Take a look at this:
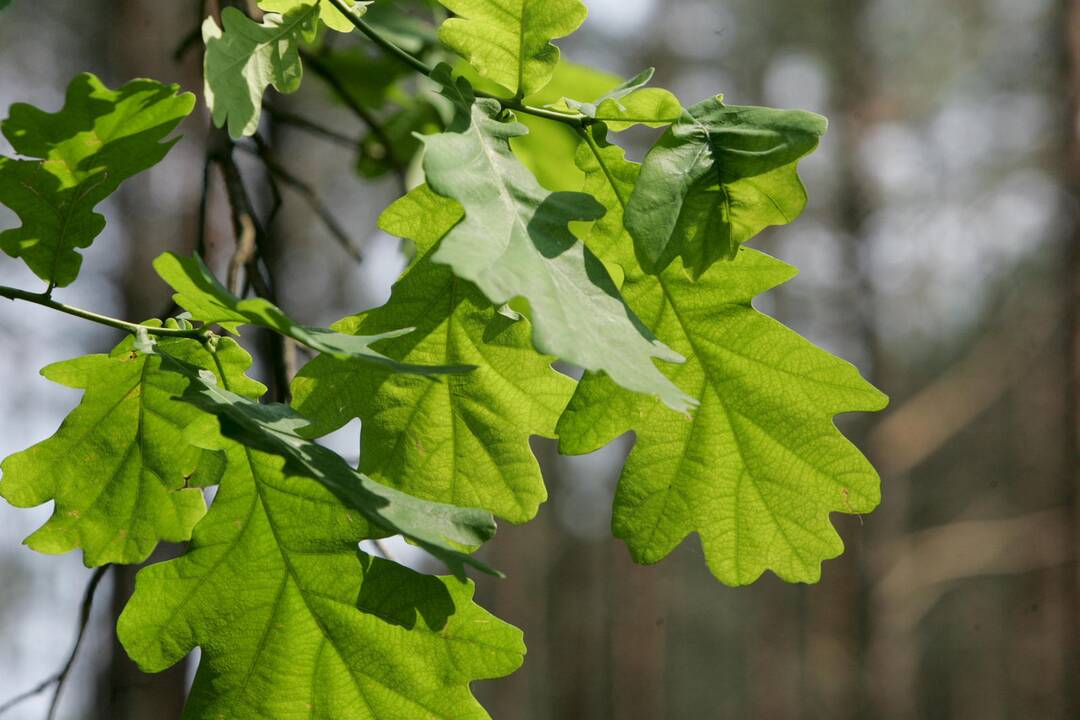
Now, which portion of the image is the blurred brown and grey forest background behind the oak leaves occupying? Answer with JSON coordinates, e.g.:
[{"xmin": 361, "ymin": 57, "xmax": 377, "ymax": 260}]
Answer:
[{"xmin": 0, "ymin": 0, "xmax": 1080, "ymax": 720}]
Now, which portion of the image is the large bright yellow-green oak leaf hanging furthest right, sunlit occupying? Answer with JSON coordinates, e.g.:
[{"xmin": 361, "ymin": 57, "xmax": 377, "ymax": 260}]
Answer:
[{"xmin": 558, "ymin": 129, "xmax": 887, "ymax": 585}]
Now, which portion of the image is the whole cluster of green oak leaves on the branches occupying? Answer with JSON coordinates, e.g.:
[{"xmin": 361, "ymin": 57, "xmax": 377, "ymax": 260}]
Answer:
[{"xmin": 0, "ymin": 0, "xmax": 886, "ymax": 718}]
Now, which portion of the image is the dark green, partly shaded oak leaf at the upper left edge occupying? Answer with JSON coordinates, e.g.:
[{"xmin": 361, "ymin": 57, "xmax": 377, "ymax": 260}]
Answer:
[{"xmin": 0, "ymin": 73, "xmax": 194, "ymax": 287}]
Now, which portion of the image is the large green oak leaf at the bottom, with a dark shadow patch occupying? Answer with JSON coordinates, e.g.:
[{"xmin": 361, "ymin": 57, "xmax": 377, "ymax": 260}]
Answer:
[{"xmin": 117, "ymin": 427, "xmax": 525, "ymax": 720}]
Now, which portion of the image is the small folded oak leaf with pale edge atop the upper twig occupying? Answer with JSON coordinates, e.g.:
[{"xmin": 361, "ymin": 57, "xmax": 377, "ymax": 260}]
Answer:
[{"xmin": 552, "ymin": 68, "xmax": 685, "ymax": 133}]
